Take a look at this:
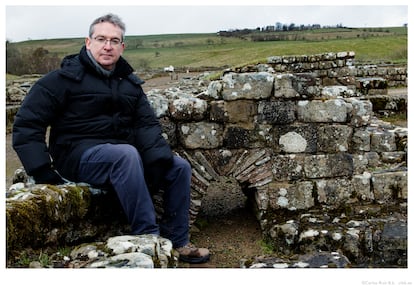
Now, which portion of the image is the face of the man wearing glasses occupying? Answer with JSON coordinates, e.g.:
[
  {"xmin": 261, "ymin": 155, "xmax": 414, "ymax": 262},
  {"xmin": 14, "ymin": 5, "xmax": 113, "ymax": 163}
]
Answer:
[{"xmin": 85, "ymin": 22, "xmax": 125, "ymax": 70}]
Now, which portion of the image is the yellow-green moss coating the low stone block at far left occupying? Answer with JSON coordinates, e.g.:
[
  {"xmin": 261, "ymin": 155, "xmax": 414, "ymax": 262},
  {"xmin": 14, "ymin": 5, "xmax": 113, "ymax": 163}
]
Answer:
[{"xmin": 6, "ymin": 185, "xmax": 91, "ymax": 255}]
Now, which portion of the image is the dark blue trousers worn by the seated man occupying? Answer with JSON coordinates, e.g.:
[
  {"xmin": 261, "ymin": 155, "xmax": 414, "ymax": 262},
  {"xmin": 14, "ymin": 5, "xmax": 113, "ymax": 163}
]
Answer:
[{"xmin": 78, "ymin": 144, "xmax": 191, "ymax": 248}]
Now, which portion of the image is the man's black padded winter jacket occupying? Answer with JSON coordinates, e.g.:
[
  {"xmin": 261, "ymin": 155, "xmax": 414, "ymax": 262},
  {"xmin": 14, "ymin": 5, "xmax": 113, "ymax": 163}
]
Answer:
[{"xmin": 13, "ymin": 47, "xmax": 172, "ymax": 181}]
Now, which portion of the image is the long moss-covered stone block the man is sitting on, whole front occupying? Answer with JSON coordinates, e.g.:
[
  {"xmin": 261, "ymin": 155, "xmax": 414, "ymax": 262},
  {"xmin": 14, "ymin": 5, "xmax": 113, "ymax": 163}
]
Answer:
[{"xmin": 6, "ymin": 183, "xmax": 129, "ymax": 252}]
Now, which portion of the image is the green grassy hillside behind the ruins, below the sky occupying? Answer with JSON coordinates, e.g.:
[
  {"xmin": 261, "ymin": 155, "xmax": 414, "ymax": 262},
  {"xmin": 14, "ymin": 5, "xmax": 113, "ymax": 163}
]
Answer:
[{"xmin": 7, "ymin": 27, "xmax": 407, "ymax": 73}]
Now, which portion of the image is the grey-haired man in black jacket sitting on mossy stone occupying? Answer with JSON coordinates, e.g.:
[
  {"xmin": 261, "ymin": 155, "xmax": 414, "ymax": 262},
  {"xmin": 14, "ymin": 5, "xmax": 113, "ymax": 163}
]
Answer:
[{"xmin": 13, "ymin": 14, "xmax": 210, "ymax": 263}]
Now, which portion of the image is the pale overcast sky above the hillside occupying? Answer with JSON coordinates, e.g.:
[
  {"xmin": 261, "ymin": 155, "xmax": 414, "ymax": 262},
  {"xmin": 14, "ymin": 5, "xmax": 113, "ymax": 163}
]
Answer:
[{"xmin": 4, "ymin": 0, "xmax": 408, "ymax": 42}]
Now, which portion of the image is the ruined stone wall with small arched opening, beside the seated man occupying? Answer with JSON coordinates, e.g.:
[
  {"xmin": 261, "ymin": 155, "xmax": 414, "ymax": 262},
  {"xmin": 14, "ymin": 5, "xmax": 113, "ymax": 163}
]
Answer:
[{"xmin": 149, "ymin": 53, "xmax": 408, "ymax": 264}]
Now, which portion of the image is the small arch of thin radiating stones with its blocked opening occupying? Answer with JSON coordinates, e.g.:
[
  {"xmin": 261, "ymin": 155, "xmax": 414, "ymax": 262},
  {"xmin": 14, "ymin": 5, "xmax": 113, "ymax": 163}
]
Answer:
[{"xmin": 179, "ymin": 149, "xmax": 273, "ymax": 223}]
